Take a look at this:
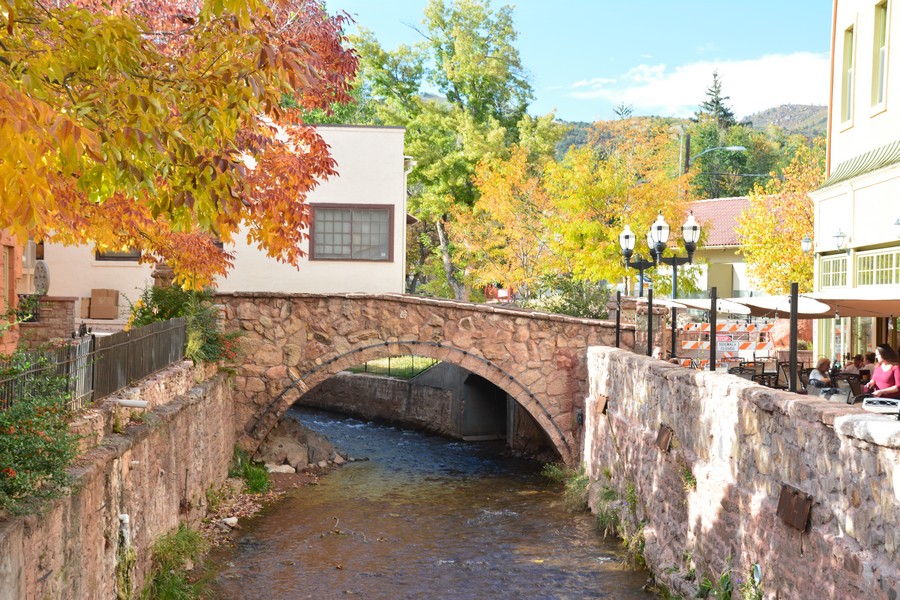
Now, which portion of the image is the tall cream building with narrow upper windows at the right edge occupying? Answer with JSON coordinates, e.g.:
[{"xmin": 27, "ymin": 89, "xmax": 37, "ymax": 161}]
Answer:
[{"xmin": 811, "ymin": 0, "xmax": 900, "ymax": 358}]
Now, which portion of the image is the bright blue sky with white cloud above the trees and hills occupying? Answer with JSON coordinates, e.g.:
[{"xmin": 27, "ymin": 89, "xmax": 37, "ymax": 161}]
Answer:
[{"xmin": 327, "ymin": 0, "xmax": 832, "ymax": 121}]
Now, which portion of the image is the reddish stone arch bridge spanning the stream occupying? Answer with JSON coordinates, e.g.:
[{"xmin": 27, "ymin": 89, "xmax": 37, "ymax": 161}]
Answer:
[{"xmin": 217, "ymin": 293, "xmax": 633, "ymax": 464}]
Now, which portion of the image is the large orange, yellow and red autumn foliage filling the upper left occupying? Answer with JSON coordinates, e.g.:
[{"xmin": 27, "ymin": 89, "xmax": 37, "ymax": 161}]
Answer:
[{"xmin": 0, "ymin": 0, "xmax": 357, "ymax": 286}]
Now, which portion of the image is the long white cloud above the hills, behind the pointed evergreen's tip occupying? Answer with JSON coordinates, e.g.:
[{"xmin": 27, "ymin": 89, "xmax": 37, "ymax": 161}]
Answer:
[{"xmin": 569, "ymin": 52, "xmax": 829, "ymax": 119}]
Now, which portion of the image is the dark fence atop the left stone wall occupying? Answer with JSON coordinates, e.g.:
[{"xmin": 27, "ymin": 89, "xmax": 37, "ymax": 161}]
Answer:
[{"xmin": 0, "ymin": 318, "xmax": 187, "ymax": 410}]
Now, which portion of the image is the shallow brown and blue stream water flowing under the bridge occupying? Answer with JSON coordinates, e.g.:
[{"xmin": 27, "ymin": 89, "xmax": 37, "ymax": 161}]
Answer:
[{"xmin": 212, "ymin": 409, "xmax": 650, "ymax": 599}]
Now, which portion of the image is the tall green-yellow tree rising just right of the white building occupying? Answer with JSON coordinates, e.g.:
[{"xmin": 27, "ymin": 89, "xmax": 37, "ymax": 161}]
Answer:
[{"xmin": 355, "ymin": 0, "xmax": 562, "ymax": 299}]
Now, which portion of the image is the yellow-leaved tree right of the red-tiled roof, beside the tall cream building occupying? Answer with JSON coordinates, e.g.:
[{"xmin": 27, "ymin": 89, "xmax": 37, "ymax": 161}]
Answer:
[{"xmin": 736, "ymin": 139, "xmax": 825, "ymax": 294}]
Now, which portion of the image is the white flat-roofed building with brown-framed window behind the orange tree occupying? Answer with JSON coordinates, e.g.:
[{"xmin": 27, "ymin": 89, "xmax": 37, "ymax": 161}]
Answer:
[{"xmin": 43, "ymin": 125, "xmax": 411, "ymax": 316}]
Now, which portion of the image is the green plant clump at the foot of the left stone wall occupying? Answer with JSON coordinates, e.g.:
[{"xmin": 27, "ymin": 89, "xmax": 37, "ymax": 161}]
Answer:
[{"xmin": 141, "ymin": 525, "xmax": 209, "ymax": 600}]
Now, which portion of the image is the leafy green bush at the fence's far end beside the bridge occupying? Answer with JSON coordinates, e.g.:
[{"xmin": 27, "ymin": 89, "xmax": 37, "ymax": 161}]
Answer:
[{"xmin": 128, "ymin": 286, "xmax": 240, "ymax": 363}]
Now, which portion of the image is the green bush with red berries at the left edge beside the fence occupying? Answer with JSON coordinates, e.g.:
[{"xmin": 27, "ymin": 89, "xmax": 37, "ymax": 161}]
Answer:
[{"xmin": 0, "ymin": 353, "xmax": 78, "ymax": 513}]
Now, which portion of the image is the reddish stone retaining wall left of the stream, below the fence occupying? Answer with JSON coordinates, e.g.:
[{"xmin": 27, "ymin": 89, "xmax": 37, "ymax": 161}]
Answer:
[{"xmin": 0, "ymin": 362, "xmax": 235, "ymax": 600}]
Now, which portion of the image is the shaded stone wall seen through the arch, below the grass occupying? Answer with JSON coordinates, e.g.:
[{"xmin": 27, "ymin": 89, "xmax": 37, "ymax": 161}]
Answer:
[{"xmin": 299, "ymin": 373, "xmax": 454, "ymax": 435}]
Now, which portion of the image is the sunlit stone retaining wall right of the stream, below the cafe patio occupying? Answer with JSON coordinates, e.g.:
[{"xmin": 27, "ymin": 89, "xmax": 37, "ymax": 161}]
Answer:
[{"xmin": 583, "ymin": 347, "xmax": 900, "ymax": 600}]
